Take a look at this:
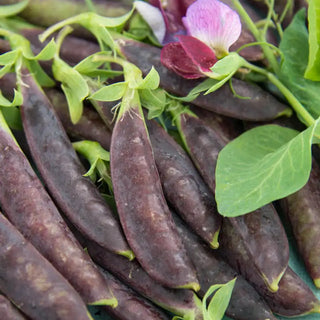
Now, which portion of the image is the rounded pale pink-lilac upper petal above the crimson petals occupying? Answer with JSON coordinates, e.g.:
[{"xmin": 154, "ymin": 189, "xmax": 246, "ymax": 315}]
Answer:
[{"xmin": 182, "ymin": 0, "xmax": 241, "ymax": 58}]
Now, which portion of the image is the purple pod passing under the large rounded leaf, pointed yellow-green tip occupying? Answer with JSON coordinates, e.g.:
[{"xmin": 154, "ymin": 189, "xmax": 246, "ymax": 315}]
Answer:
[{"xmin": 176, "ymin": 112, "xmax": 289, "ymax": 291}]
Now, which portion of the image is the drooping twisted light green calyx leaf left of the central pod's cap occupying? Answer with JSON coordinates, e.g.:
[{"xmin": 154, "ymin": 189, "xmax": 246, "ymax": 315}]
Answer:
[{"xmin": 52, "ymin": 56, "xmax": 89, "ymax": 123}]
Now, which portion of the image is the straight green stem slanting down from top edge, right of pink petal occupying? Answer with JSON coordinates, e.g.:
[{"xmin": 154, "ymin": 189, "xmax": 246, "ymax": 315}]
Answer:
[{"xmin": 231, "ymin": 0, "xmax": 279, "ymax": 73}]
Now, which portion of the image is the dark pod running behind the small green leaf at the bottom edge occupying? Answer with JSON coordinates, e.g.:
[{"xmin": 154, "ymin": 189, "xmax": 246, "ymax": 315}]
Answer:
[{"xmin": 174, "ymin": 215, "xmax": 276, "ymax": 320}]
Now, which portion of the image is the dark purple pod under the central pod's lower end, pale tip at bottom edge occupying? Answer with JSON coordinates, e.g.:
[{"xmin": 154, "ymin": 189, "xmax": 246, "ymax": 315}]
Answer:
[{"xmin": 86, "ymin": 242, "xmax": 202, "ymax": 320}]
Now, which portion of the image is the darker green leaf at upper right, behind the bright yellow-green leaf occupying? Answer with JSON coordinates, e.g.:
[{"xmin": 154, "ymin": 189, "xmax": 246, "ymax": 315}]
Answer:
[{"xmin": 278, "ymin": 10, "xmax": 320, "ymax": 118}]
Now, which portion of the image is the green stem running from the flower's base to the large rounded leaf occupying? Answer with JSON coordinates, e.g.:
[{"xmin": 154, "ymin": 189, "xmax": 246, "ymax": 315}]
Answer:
[{"xmin": 244, "ymin": 62, "xmax": 315, "ymax": 127}]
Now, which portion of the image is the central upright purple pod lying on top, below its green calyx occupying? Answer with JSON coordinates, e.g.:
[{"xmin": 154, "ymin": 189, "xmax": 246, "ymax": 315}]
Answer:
[{"xmin": 110, "ymin": 106, "xmax": 199, "ymax": 290}]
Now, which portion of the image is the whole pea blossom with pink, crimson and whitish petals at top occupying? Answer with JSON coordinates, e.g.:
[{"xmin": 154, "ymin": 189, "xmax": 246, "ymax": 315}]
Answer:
[{"xmin": 135, "ymin": 0, "xmax": 241, "ymax": 79}]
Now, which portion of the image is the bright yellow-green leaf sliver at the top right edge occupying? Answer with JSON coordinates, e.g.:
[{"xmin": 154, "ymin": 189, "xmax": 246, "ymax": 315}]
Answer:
[{"xmin": 304, "ymin": 0, "xmax": 320, "ymax": 81}]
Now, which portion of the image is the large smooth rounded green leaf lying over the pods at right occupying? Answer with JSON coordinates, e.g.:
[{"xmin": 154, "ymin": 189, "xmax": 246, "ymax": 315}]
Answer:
[{"xmin": 216, "ymin": 121, "xmax": 318, "ymax": 217}]
